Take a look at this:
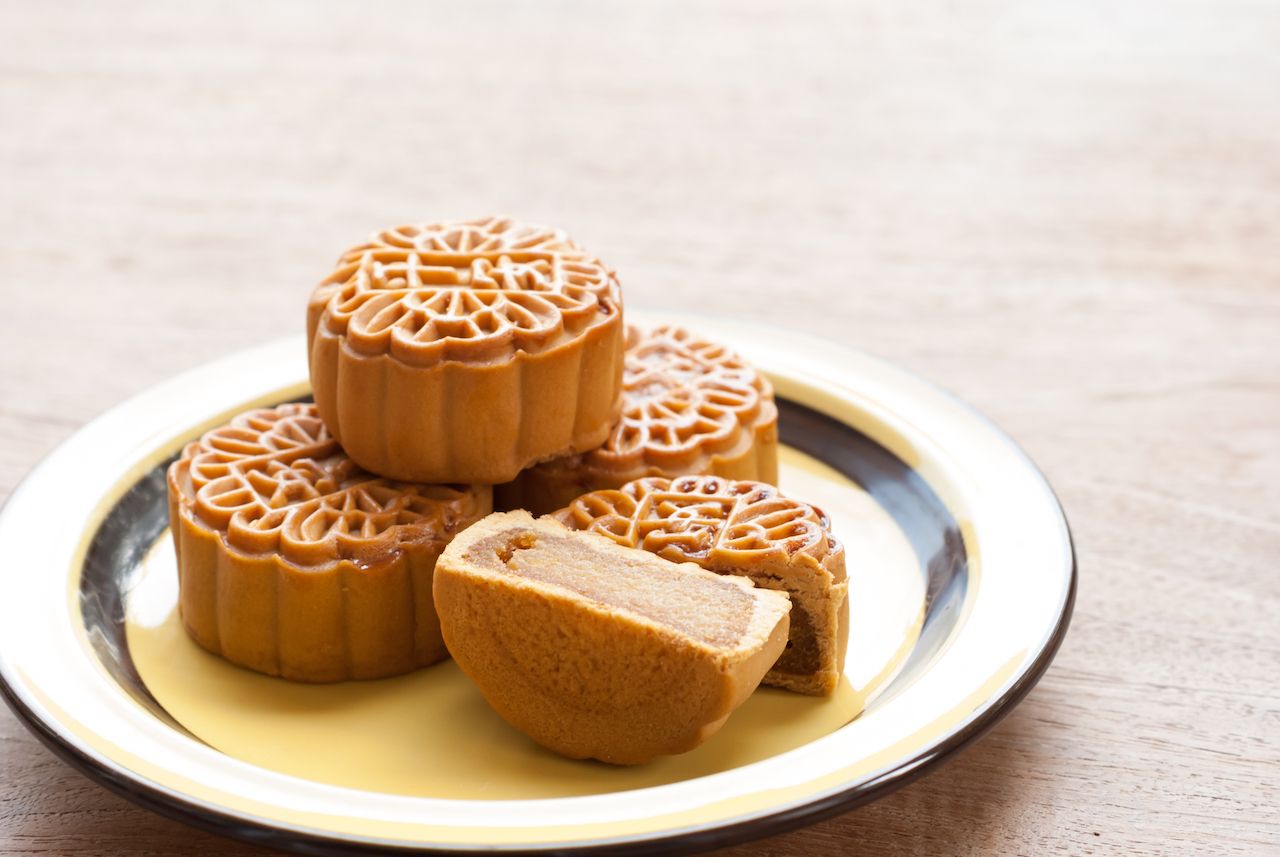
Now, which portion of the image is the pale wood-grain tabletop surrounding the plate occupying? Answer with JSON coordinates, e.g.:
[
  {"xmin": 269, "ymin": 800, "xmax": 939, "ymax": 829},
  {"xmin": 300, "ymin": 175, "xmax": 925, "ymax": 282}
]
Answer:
[{"xmin": 0, "ymin": 0, "xmax": 1280, "ymax": 856}]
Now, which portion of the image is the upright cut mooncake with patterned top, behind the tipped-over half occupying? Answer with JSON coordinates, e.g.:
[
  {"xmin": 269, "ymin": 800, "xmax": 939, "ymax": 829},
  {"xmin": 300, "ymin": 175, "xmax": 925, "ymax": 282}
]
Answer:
[{"xmin": 556, "ymin": 476, "xmax": 849, "ymax": 695}]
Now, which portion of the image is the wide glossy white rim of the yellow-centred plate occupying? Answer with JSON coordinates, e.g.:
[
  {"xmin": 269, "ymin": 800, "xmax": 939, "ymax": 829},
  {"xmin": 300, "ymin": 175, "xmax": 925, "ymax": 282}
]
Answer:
[{"xmin": 0, "ymin": 311, "xmax": 1075, "ymax": 851}]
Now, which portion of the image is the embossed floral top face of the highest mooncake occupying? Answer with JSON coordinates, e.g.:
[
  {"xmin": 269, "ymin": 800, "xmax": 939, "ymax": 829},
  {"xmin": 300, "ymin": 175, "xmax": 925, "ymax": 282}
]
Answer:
[{"xmin": 310, "ymin": 217, "xmax": 622, "ymax": 365}]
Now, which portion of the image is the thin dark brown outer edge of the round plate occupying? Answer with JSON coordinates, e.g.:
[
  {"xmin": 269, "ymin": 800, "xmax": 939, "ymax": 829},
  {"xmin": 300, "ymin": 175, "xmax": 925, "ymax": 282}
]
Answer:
[{"xmin": 0, "ymin": 318, "xmax": 1079, "ymax": 854}]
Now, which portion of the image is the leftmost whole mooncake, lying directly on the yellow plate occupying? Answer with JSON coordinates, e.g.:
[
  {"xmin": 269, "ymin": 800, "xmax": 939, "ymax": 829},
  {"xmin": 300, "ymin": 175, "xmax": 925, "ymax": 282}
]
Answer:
[{"xmin": 169, "ymin": 404, "xmax": 492, "ymax": 682}]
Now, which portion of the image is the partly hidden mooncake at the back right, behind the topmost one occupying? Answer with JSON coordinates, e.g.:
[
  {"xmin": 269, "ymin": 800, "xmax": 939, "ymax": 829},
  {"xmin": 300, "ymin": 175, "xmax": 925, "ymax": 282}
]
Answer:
[{"xmin": 494, "ymin": 327, "xmax": 778, "ymax": 514}]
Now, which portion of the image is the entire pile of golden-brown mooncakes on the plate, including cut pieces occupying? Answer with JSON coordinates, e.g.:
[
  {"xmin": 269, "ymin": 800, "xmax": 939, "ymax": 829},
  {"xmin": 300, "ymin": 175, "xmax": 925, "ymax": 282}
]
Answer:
[{"xmin": 169, "ymin": 217, "xmax": 847, "ymax": 764}]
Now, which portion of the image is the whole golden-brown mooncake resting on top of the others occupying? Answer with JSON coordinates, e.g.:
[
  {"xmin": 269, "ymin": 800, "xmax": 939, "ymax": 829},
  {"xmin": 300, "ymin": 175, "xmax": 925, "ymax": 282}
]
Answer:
[{"xmin": 307, "ymin": 217, "xmax": 625, "ymax": 484}]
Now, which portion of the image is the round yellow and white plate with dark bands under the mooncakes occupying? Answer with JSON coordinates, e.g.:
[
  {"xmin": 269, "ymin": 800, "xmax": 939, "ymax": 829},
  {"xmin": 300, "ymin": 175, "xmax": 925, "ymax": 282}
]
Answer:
[{"xmin": 0, "ymin": 312, "xmax": 1075, "ymax": 853}]
